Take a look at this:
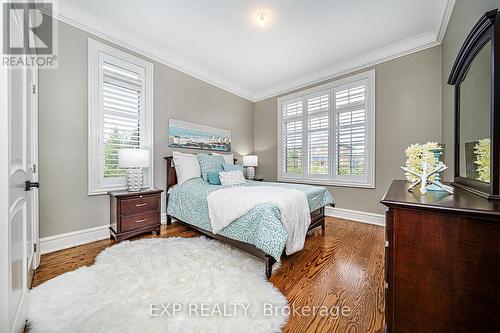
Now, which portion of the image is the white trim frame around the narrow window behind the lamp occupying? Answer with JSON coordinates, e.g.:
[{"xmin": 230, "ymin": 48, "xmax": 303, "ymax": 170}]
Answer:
[{"xmin": 87, "ymin": 38, "xmax": 154, "ymax": 196}]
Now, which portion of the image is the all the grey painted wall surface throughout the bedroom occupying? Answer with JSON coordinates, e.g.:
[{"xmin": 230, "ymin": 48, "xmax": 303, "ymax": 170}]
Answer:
[{"xmin": 39, "ymin": 0, "xmax": 500, "ymax": 237}]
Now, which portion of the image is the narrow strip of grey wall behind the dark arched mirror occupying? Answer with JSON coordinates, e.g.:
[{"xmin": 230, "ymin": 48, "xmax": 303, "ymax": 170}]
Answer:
[{"xmin": 441, "ymin": 0, "xmax": 500, "ymax": 180}]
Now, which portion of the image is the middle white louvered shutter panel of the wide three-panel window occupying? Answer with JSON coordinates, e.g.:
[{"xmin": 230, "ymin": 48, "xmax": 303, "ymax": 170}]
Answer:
[{"xmin": 306, "ymin": 90, "xmax": 330, "ymax": 176}]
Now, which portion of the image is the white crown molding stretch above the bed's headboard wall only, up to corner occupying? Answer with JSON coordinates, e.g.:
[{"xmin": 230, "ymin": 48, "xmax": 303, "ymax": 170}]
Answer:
[{"xmin": 53, "ymin": 0, "xmax": 254, "ymax": 101}]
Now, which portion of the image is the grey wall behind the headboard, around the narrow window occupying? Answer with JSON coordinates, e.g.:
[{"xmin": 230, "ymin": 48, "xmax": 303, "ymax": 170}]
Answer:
[{"xmin": 39, "ymin": 22, "xmax": 253, "ymax": 237}]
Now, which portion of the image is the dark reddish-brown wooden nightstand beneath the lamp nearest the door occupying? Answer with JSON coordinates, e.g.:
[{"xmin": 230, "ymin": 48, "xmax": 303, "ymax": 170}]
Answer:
[{"xmin": 109, "ymin": 189, "xmax": 163, "ymax": 242}]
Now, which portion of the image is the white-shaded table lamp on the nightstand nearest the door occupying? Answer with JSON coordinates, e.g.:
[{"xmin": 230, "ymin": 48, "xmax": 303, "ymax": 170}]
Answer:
[{"xmin": 118, "ymin": 148, "xmax": 149, "ymax": 192}]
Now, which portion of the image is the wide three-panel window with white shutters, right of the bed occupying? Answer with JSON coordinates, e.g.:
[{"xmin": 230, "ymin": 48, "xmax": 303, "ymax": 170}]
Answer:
[{"xmin": 278, "ymin": 70, "xmax": 375, "ymax": 188}]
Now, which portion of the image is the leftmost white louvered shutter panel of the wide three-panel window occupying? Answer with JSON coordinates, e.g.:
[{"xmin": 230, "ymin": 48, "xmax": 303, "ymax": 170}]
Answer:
[{"xmin": 281, "ymin": 100, "xmax": 304, "ymax": 176}]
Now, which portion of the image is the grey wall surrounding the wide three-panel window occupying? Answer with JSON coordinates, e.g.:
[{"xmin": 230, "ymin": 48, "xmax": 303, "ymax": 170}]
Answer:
[{"xmin": 254, "ymin": 46, "xmax": 441, "ymax": 213}]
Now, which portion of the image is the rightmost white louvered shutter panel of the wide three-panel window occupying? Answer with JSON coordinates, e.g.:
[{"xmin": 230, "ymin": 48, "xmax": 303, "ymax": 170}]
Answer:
[{"xmin": 333, "ymin": 80, "xmax": 368, "ymax": 178}]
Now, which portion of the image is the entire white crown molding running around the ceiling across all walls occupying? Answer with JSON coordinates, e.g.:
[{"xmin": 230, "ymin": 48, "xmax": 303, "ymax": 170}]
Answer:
[{"xmin": 49, "ymin": 0, "xmax": 455, "ymax": 102}]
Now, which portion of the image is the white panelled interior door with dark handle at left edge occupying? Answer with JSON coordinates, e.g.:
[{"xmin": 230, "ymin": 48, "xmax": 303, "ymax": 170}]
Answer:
[{"xmin": 0, "ymin": 5, "xmax": 38, "ymax": 332}]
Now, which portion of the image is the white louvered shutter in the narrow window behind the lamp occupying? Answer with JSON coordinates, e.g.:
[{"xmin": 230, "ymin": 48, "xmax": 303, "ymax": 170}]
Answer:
[{"xmin": 100, "ymin": 54, "xmax": 144, "ymax": 181}]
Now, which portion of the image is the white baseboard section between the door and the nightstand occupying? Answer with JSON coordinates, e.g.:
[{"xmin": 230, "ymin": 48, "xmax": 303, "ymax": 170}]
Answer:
[{"xmin": 40, "ymin": 224, "xmax": 109, "ymax": 254}]
